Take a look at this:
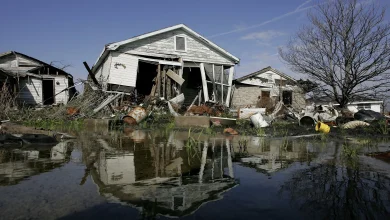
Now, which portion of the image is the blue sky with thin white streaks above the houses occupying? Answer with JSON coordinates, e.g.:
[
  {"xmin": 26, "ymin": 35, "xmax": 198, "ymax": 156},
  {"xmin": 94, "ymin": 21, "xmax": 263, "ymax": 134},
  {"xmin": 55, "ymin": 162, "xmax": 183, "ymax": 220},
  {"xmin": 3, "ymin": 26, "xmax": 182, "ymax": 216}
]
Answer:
[{"xmin": 0, "ymin": 0, "xmax": 390, "ymax": 86}]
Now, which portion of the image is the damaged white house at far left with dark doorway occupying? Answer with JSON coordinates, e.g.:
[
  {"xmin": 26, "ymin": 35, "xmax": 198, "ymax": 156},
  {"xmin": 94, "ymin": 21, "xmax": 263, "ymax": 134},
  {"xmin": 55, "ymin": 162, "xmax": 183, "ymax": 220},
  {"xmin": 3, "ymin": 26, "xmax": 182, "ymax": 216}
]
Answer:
[{"xmin": 0, "ymin": 51, "xmax": 76, "ymax": 105}]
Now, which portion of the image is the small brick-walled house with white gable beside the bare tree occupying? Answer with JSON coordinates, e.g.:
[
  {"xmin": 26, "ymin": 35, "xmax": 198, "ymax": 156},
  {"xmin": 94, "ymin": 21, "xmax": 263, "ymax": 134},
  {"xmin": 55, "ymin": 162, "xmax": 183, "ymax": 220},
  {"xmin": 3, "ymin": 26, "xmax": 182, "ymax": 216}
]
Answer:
[{"xmin": 232, "ymin": 66, "xmax": 305, "ymax": 110}]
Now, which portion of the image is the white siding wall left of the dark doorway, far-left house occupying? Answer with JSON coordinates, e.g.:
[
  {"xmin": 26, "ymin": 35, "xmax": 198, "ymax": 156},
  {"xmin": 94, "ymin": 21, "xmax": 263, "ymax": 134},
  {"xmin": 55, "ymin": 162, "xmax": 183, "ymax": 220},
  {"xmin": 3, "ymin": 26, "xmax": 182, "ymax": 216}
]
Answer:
[{"xmin": 18, "ymin": 77, "xmax": 42, "ymax": 104}]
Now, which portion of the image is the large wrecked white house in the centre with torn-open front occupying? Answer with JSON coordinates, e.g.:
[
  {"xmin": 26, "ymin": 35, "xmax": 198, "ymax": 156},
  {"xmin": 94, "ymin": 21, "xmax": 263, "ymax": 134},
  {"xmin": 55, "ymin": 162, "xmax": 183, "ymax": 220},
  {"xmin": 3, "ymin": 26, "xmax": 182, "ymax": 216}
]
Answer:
[{"xmin": 92, "ymin": 24, "xmax": 239, "ymax": 105}]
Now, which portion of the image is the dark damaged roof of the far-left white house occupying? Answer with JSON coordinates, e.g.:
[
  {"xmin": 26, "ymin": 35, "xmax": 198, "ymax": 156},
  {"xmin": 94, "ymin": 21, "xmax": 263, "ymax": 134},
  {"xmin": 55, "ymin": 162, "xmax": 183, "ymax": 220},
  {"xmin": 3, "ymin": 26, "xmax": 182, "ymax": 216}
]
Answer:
[{"xmin": 0, "ymin": 51, "xmax": 72, "ymax": 77}]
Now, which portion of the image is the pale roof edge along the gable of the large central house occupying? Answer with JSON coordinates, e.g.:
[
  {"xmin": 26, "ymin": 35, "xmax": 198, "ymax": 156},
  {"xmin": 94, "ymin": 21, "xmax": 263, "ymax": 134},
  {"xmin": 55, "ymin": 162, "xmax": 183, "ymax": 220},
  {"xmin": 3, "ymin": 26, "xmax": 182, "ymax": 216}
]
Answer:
[{"xmin": 93, "ymin": 24, "xmax": 240, "ymax": 69}]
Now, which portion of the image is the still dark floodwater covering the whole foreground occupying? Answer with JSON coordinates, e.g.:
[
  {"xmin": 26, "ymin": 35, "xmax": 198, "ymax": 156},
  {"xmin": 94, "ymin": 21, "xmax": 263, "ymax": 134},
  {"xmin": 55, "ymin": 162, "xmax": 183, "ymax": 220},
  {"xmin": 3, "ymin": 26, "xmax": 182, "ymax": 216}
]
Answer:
[{"xmin": 0, "ymin": 129, "xmax": 390, "ymax": 219}]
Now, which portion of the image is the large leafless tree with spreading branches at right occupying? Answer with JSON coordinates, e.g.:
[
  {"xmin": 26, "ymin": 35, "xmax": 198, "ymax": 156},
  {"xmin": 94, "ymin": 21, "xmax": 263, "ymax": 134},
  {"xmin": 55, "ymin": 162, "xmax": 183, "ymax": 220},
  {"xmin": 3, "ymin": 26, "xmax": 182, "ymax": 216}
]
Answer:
[{"xmin": 279, "ymin": 0, "xmax": 390, "ymax": 107}]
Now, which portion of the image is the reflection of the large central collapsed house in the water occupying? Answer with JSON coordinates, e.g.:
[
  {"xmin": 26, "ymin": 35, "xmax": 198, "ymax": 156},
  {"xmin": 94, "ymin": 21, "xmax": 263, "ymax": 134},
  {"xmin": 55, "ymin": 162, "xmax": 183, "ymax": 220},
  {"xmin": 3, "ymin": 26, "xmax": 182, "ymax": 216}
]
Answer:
[{"xmin": 92, "ymin": 131, "xmax": 237, "ymax": 216}]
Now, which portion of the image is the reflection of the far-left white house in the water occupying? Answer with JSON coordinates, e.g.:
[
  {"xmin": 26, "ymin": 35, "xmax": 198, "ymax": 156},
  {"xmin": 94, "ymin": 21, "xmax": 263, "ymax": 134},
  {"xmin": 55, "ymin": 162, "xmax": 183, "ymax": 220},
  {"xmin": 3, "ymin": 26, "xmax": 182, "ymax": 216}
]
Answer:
[{"xmin": 0, "ymin": 142, "xmax": 72, "ymax": 185}]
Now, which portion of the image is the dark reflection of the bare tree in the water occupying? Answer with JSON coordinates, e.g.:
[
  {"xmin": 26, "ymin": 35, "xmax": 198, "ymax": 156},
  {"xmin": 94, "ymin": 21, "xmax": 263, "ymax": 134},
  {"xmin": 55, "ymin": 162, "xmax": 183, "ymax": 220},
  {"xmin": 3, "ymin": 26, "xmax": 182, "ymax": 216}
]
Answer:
[{"xmin": 280, "ymin": 142, "xmax": 390, "ymax": 219}]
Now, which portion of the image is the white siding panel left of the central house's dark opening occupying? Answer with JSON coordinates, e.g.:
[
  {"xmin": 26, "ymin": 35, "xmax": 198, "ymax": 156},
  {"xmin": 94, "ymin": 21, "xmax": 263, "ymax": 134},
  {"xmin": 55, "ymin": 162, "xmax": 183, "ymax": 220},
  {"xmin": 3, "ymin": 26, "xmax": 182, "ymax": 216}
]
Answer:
[{"xmin": 109, "ymin": 52, "xmax": 138, "ymax": 87}]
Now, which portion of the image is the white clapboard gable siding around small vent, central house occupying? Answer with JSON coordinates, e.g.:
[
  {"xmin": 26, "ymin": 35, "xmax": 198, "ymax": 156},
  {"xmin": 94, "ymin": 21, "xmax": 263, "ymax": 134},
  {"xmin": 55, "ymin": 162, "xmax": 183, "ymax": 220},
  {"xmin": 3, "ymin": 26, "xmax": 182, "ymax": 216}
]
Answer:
[{"xmin": 119, "ymin": 30, "xmax": 234, "ymax": 65}]
